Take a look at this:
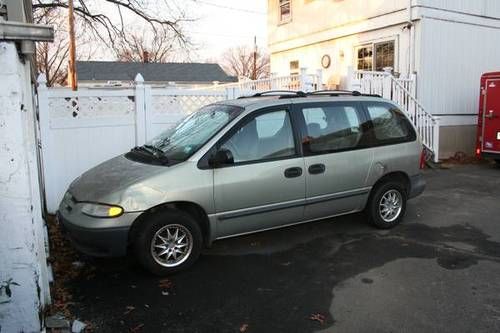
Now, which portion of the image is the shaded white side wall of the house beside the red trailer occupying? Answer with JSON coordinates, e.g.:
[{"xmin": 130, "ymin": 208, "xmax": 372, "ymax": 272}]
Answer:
[{"xmin": 419, "ymin": 16, "xmax": 500, "ymax": 126}]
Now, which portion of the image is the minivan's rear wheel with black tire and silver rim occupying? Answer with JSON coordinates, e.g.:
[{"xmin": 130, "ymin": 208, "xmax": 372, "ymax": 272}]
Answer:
[{"xmin": 366, "ymin": 181, "xmax": 407, "ymax": 229}]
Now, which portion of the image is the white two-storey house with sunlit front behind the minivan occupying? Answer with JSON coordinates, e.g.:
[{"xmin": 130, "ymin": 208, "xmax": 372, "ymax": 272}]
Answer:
[{"xmin": 268, "ymin": 0, "xmax": 500, "ymax": 157}]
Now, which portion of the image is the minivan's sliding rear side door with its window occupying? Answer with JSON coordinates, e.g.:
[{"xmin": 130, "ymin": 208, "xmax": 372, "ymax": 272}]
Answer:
[{"xmin": 294, "ymin": 102, "xmax": 373, "ymax": 220}]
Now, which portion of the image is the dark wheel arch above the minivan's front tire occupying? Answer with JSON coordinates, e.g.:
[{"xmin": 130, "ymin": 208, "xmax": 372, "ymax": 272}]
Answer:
[{"xmin": 128, "ymin": 201, "xmax": 211, "ymax": 248}]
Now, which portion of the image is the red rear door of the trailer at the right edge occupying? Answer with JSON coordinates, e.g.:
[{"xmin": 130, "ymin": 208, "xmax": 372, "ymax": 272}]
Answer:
[{"xmin": 482, "ymin": 79, "xmax": 500, "ymax": 153}]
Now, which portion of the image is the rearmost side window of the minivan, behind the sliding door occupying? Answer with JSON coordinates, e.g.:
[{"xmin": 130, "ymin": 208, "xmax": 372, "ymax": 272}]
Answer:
[{"xmin": 365, "ymin": 103, "xmax": 416, "ymax": 145}]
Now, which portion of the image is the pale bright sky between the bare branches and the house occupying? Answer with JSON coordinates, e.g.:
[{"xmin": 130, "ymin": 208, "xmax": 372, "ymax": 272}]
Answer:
[{"xmin": 93, "ymin": 0, "xmax": 267, "ymax": 62}]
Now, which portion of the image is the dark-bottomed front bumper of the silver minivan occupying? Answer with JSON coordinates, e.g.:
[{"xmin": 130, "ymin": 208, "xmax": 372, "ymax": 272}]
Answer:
[{"xmin": 57, "ymin": 197, "xmax": 140, "ymax": 257}]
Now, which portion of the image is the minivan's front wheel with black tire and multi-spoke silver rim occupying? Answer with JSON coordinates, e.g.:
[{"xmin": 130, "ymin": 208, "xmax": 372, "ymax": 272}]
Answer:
[{"xmin": 134, "ymin": 210, "xmax": 203, "ymax": 276}]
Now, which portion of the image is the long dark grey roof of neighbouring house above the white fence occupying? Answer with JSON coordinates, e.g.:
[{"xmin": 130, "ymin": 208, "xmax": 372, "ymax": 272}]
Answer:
[{"xmin": 76, "ymin": 61, "xmax": 238, "ymax": 83}]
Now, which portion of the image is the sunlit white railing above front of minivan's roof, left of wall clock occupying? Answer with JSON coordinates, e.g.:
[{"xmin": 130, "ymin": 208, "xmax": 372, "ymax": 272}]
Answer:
[{"xmin": 203, "ymin": 68, "xmax": 323, "ymax": 98}]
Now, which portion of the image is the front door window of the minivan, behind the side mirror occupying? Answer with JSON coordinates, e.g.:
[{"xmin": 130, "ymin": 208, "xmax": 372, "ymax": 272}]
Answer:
[{"xmin": 221, "ymin": 110, "xmax": 295, "ymax": 163}]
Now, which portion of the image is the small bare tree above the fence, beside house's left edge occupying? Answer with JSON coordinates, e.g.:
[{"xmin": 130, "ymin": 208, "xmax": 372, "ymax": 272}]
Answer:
[{"xmin": 221, "ymin": 46, "xmax": 270, "ymax": 79}]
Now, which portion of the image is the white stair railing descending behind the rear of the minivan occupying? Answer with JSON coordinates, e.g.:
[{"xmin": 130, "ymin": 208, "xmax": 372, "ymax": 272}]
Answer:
[{"xmin": 347, "ymin": 69, "xmax": 439, "ymax": 162}]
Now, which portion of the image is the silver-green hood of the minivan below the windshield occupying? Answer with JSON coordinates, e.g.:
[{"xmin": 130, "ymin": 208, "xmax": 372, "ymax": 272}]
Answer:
[{"xmin": 69, "ymin": 155, "xmax": 167, "ymax": 204}]
